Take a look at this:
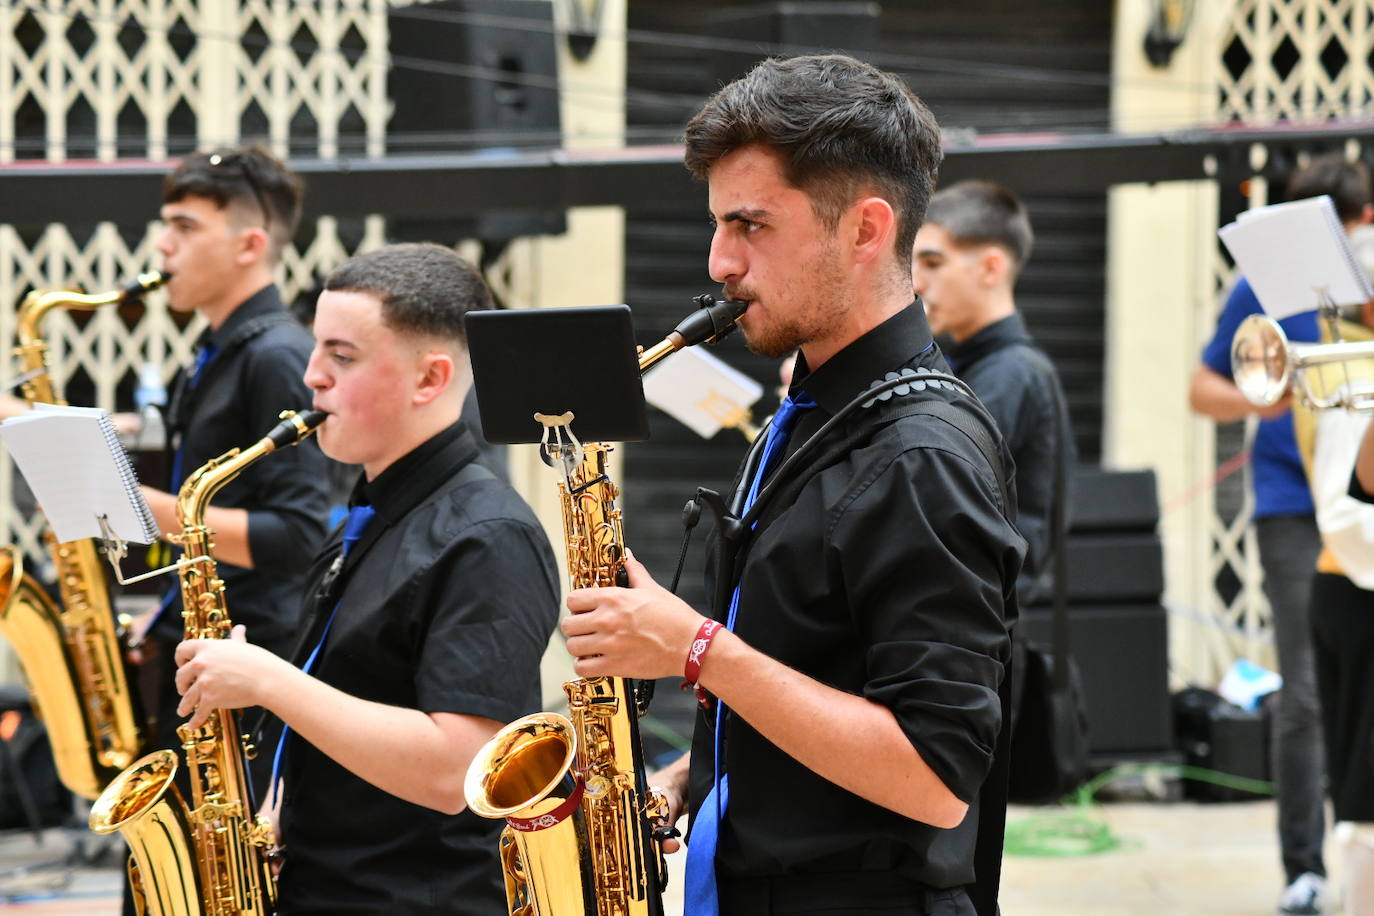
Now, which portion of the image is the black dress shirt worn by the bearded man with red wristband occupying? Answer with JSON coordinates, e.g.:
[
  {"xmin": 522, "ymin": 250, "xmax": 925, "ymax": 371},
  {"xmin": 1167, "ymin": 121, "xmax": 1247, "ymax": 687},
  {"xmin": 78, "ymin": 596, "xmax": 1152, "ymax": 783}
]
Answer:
[{"xmin": 691, "ymin": 306, "xmax": 1025, "ymax": 889}]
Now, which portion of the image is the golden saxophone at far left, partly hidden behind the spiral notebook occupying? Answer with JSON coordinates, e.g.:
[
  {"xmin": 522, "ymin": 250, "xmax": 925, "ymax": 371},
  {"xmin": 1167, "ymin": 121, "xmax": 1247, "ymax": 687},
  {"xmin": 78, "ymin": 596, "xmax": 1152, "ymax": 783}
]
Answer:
[{"xmin": 0, "ymin": 272, "xmax": 168, "ymax": 798}]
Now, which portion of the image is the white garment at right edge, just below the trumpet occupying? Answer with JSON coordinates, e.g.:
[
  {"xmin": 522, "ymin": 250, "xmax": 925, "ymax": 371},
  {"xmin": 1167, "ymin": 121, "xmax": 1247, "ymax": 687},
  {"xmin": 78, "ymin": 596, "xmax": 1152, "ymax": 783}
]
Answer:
[{"xmin": 1312, "ymin": 409, "xmax": 1374, "ymax": 589}]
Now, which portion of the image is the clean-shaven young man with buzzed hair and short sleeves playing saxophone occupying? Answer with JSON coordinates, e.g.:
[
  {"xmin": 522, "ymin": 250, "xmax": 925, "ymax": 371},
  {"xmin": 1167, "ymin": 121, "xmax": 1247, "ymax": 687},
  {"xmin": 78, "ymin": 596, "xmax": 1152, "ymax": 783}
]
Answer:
[{"xmin": 177, "ymin": 244, "xmax": 559, "ymax": 916}]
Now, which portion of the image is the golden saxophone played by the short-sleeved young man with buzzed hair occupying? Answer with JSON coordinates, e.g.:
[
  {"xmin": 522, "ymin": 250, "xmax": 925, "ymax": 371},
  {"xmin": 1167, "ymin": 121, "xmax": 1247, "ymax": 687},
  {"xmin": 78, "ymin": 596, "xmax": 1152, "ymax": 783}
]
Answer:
[{"xmin": 91, "ymin": 411, "xmax": 327, "ymax": 916}]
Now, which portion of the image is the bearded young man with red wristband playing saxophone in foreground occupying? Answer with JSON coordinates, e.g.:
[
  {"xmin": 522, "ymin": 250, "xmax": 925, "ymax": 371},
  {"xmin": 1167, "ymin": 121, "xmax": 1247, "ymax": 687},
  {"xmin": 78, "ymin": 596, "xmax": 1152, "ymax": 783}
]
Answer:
[{"xmin": 563, "ymin": 56, "xmax": 1025, "ymax": 916}]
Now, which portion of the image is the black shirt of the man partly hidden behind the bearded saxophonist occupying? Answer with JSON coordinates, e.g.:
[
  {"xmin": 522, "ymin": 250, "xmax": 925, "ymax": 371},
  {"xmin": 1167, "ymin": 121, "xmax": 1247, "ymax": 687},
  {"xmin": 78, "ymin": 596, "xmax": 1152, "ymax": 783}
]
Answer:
[{"xmin": 945, "ymin": 314, "xmax": 1076, "ymax": 606}]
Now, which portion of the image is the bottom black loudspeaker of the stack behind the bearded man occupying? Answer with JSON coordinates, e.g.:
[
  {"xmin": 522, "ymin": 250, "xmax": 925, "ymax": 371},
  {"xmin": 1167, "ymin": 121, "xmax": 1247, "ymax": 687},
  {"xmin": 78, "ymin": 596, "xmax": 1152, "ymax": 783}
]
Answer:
[{"xmin": 1013, "ymin": 604, "xmax": 1173, "ymax": 766}]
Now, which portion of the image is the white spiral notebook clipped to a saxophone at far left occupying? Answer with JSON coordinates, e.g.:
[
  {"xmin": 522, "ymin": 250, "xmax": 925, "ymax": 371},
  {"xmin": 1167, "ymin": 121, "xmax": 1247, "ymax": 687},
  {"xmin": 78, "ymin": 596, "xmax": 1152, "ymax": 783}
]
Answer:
[{"xmin": 0, "ymin": 404, "xmax": 158, "ymax": 544}]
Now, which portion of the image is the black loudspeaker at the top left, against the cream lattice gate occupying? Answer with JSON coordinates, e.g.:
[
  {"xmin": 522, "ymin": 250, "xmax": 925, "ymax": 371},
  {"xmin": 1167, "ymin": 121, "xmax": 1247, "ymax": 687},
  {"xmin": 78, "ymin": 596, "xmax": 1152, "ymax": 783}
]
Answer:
[{"xmin": 386, "ymin": 0, "xmax": 567, "ymax": 242}]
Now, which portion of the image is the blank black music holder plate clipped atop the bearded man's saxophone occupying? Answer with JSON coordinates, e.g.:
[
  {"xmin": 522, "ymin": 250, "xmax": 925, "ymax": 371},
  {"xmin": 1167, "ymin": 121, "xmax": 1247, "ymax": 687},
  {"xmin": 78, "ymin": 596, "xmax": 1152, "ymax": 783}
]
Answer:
[{"xmin": 464, "ymin": 305, "xmax": 649, "ymax": 444}]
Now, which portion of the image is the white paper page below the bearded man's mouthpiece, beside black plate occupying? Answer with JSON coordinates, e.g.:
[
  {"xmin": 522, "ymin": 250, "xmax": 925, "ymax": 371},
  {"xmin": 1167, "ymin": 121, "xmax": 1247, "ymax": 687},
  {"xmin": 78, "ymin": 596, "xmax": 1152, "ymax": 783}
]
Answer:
[{"xmin": 644, "ymin": 347, "xmax": 764, "ymax": 439}]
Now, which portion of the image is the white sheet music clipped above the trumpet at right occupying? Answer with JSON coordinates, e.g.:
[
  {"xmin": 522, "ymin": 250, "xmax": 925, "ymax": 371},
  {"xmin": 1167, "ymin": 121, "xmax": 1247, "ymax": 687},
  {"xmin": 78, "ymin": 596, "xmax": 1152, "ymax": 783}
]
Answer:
[{"xmin": 1217, "ymin": 195, "xmax": 1374, "ymax": 319}]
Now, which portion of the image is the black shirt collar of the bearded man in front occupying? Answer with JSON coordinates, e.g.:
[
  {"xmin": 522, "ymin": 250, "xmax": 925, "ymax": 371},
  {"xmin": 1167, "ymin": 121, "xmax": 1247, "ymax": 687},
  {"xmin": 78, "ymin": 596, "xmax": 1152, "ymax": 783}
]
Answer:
[{"xmin": 789, "ymin": 302, "xmax": 932, "ymax": 413}]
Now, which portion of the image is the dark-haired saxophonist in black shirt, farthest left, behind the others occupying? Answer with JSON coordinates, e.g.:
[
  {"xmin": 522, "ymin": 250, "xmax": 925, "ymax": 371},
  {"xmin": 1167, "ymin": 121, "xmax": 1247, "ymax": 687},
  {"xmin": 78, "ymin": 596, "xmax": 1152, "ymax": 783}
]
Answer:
[{"xmin": 126, "ymin": 147, "xmax": 328, "ymax": 829}]
